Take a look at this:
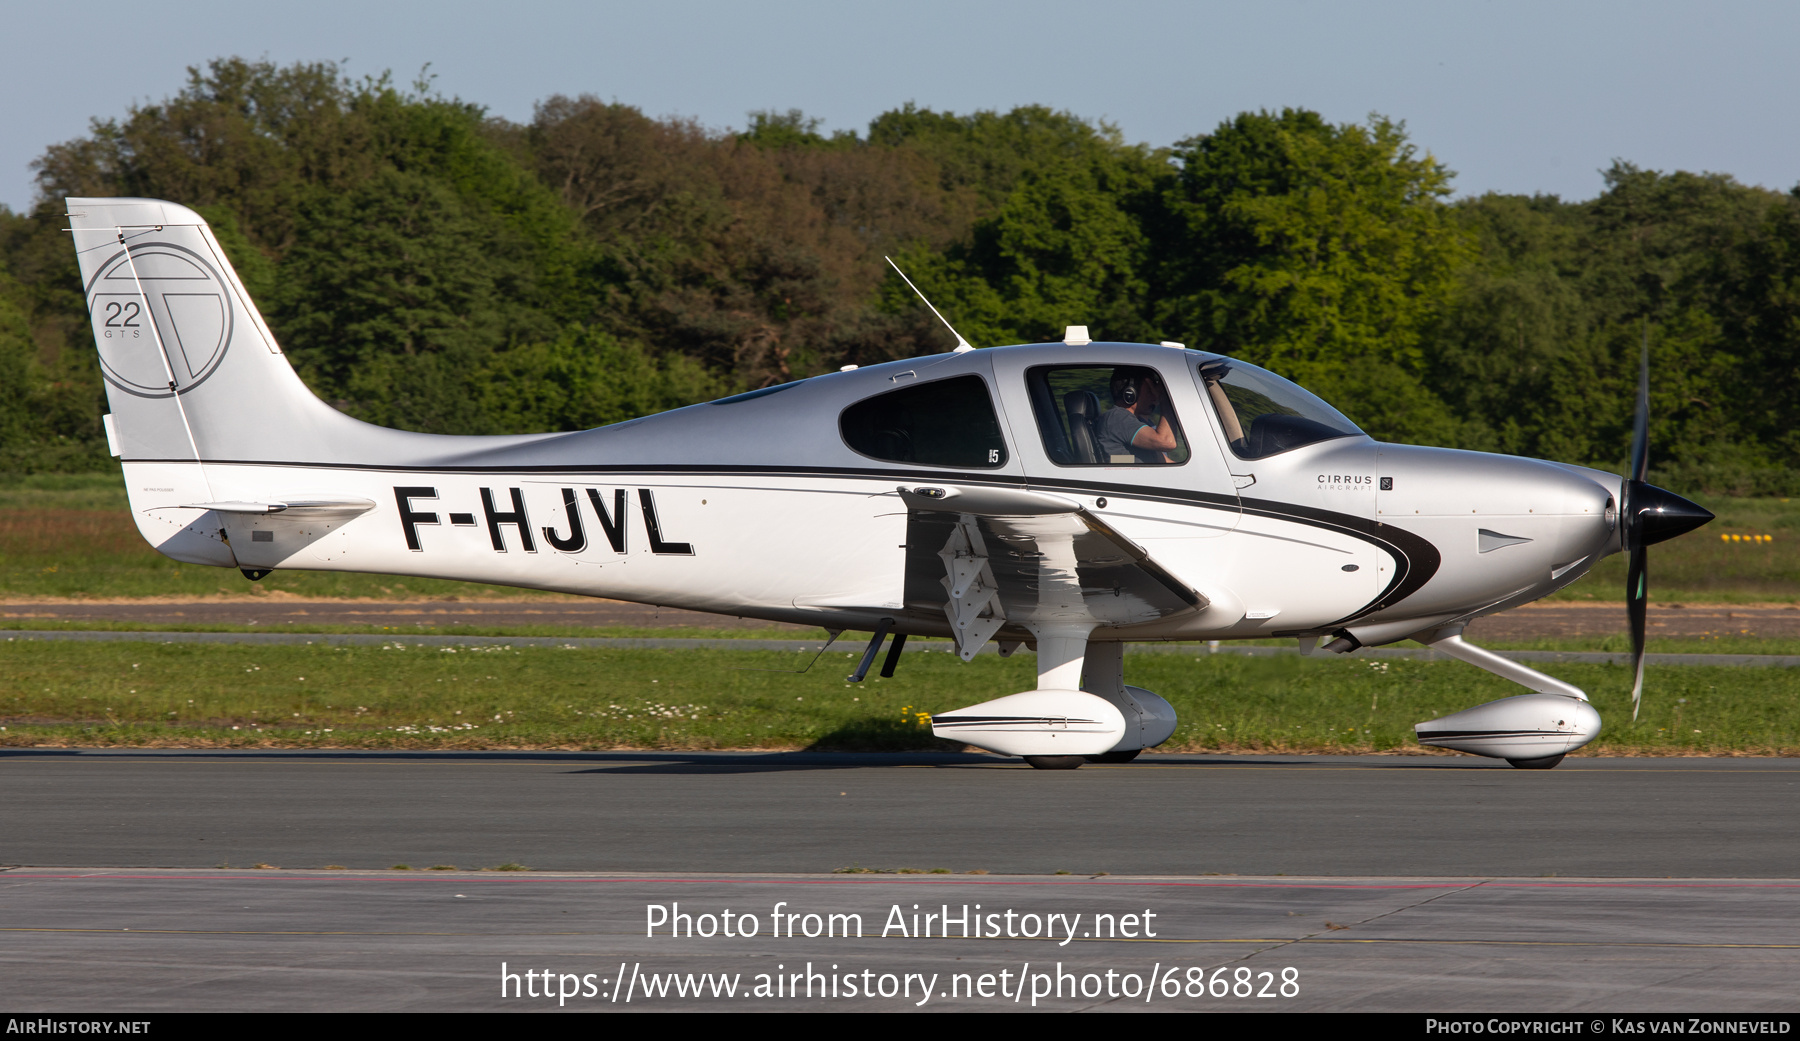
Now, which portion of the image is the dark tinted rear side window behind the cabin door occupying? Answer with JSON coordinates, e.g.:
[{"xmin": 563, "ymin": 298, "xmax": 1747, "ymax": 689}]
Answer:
[{"xmin": 837, "ymin": 376, "xmax": 1006, "ymax": 470}]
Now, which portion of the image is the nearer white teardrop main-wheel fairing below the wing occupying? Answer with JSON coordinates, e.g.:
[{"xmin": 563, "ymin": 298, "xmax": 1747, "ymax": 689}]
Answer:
[{"xmin": 931, "ymin": 690, "xmax": 1116, "ymax": 756}]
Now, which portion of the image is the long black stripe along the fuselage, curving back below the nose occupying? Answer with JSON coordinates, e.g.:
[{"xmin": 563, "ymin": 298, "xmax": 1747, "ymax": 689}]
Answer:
[{"xmin": 124, "ymin": 452, "xmax": 1444, "ymax": 615}]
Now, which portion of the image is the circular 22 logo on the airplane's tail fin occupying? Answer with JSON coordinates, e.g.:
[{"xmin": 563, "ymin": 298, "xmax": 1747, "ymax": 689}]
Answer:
[{"xmin": 88, "ymin": 243, "xmax": 234, "ymax": 398}]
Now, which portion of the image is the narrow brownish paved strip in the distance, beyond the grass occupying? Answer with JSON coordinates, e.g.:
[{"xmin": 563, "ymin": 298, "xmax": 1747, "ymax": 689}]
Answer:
[{"xmin": 0, "ymin": 596, "xmax": 1800, "ymax": 643}]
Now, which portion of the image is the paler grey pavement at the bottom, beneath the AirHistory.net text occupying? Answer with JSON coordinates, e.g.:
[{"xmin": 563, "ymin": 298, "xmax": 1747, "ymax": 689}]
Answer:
[{"xmin": 0, "ymin": 870, "xmax": 1800, "ymax": 1008}]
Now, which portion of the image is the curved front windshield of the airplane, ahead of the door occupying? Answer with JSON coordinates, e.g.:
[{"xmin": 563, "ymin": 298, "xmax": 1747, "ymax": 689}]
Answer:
[{"xmin": 1193, "ymin": 355, "xmax": 1363, "ymax": 459}]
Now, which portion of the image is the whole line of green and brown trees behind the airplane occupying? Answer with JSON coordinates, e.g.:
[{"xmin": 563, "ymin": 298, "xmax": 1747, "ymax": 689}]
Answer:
[{"xmin": 0, "ymin": 58, "xmax": 1800, "ymax": 493}]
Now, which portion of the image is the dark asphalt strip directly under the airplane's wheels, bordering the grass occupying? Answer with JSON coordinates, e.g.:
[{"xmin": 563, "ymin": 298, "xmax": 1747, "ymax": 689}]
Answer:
[{"xmin": 0, "ymin": 749, "xmax": 1800, "ymax": 877}]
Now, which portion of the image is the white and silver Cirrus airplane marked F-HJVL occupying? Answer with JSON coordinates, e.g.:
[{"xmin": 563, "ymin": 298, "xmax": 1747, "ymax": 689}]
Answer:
[{"xmin": 68, "ymin": 198, "xmax": 1712, "ymax": 769}]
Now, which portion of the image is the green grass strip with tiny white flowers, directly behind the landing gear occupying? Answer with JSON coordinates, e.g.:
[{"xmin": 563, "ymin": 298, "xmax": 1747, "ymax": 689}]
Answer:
[{"xmin": 0, "ymin": 643, "xmax": 1800, "ymax": 755}]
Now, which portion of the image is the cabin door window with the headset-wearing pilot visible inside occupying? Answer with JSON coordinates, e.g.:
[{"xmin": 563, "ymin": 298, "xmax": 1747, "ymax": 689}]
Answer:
[{"xmin": 1026, "ymin": 366, "xmax": 1188, "ymax": 466}]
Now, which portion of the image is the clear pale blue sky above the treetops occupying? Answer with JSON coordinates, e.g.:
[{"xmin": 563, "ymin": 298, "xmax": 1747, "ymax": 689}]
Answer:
[{"xmin": 0, "ymin": 0, "xmax": 1800, "ymax": 209}]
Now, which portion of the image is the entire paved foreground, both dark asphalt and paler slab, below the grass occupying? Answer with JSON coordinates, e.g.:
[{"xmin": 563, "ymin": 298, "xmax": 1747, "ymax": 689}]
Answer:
[{"xmin": 0, "ymin": 749, "xmax": 1800, "ymax": 1012}]
